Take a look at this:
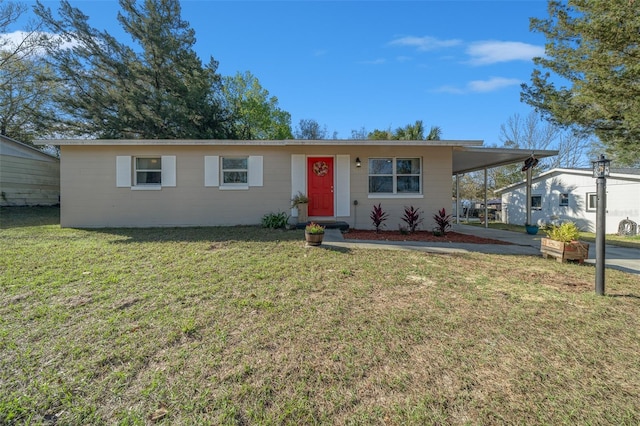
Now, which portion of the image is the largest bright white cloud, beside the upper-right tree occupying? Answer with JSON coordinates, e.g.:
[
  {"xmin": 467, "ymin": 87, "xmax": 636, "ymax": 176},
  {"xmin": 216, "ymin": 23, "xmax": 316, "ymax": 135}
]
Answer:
[{"xmin": 467, "ymin": 41, "xmax": 544, "ymax": 65}]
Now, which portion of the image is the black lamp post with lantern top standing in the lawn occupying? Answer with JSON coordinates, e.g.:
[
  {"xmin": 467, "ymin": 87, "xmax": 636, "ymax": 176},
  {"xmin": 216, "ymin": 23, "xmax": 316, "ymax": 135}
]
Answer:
[{"xmin": 593, "ymin": 154, "xmax": 611, "ymax": 296}]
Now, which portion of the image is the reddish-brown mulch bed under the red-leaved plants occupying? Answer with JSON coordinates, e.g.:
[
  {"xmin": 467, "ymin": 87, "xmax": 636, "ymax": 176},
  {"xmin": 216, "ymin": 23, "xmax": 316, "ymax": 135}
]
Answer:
[{"xmin": 343, "ymin": 229, "xmax": 511, "ymax": 245}]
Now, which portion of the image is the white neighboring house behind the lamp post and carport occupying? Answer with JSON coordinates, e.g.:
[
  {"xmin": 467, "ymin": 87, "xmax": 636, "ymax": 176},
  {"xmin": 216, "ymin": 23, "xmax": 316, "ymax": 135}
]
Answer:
[{"xmin": 495, "ymin": 169, "xmax": 640, "ymax": 234}]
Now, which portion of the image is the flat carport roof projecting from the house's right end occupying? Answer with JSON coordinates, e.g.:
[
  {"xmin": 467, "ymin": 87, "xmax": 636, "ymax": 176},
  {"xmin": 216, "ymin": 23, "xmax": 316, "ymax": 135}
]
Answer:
[{"xmin": 452, "ymin": 146, "xmax": 558, "ymax": 175}]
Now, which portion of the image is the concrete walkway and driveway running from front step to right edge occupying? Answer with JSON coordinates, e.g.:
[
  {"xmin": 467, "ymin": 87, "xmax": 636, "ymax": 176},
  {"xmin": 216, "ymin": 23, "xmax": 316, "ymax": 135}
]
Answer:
[{"xmin": 323, "ymin": 224, "xmax": 640, "ymax": 274}]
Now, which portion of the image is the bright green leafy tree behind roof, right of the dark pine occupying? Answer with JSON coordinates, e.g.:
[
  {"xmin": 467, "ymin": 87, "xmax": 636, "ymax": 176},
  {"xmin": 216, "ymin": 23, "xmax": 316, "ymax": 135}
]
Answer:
[{"xmin": 222, "ymin": 71, "xmax": 293, "ymax": 140}]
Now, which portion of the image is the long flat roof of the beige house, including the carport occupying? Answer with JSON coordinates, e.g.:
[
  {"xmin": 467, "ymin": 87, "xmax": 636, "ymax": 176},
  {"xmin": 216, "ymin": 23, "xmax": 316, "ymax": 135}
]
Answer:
[{"xmin": 35, "ymin": 139, "xmax": 558, "ymax": 174}]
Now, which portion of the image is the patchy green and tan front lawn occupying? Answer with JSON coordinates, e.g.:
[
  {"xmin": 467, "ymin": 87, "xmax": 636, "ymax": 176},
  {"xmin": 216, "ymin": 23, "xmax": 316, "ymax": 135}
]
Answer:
[{"xmin": 0, "ymin": 209, "xmax": 640, "ymax": 425}]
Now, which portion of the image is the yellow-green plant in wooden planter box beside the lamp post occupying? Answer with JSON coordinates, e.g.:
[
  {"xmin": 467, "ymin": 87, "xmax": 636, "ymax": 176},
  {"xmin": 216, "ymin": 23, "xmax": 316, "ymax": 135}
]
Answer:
[{"xmin": 540, "ymin": 222, "xmax": 589, "ymax": 263}]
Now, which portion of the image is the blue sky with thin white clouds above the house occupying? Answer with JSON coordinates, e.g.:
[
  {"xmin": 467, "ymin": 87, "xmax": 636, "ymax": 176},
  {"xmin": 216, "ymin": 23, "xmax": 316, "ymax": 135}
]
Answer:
[{"xmin": 17, "ymin": 0, "xmax": 547, "ymax": 145}]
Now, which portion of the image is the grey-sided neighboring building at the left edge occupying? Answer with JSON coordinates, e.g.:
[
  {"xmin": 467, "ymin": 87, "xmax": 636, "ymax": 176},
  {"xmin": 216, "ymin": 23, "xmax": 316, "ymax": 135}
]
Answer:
[{"xmin": 0, "ymin": 135, "xmax": 60, "ymax": 206}]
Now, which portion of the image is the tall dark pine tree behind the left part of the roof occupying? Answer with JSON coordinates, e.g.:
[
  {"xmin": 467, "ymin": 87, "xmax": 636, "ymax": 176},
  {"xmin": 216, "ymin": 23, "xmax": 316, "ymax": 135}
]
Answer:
[{"xmin": 35, "ymin": 0, "xmax": 231, "ymax": 139}]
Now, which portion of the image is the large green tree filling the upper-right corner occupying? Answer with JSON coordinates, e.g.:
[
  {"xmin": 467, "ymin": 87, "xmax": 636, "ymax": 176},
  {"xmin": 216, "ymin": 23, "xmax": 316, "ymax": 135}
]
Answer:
[{"xmin": 521, "ymin": 0, "xmax": 640, "ymax": 164}]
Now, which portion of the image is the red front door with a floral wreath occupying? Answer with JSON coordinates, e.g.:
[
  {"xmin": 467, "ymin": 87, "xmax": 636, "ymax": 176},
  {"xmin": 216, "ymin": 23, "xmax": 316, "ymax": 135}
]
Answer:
[{"xmin": 307, "ymin": 157, "xmax": 333, "ymax": 216}]
